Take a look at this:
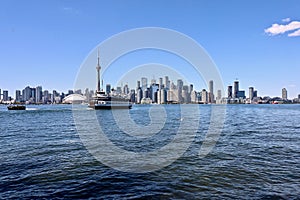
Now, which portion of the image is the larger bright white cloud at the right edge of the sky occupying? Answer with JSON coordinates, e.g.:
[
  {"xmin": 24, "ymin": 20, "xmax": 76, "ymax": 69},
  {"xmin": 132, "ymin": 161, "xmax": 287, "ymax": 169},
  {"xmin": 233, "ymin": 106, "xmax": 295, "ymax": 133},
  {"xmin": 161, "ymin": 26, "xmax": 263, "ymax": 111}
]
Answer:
[{"xmin": 265, "ymin": 21, "xmax": 300, "ymax": 37}]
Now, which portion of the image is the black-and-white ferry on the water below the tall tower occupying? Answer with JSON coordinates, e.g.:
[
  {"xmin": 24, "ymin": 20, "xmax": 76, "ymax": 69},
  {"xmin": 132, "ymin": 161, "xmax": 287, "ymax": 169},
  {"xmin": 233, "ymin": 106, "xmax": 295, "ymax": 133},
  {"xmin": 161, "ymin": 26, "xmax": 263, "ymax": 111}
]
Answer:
[{"xmin": 89, "ymin": 92, "xmax": 132, "ymax": 110}]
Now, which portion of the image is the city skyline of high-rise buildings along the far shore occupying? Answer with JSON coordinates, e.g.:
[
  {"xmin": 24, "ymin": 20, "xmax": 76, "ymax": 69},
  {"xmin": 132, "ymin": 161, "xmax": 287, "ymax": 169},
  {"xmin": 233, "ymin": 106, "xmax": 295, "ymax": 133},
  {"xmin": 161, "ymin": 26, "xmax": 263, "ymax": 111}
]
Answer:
[{"xmin": 0, "ymin": 76, "xmax": 300, "ymax": 104}]
